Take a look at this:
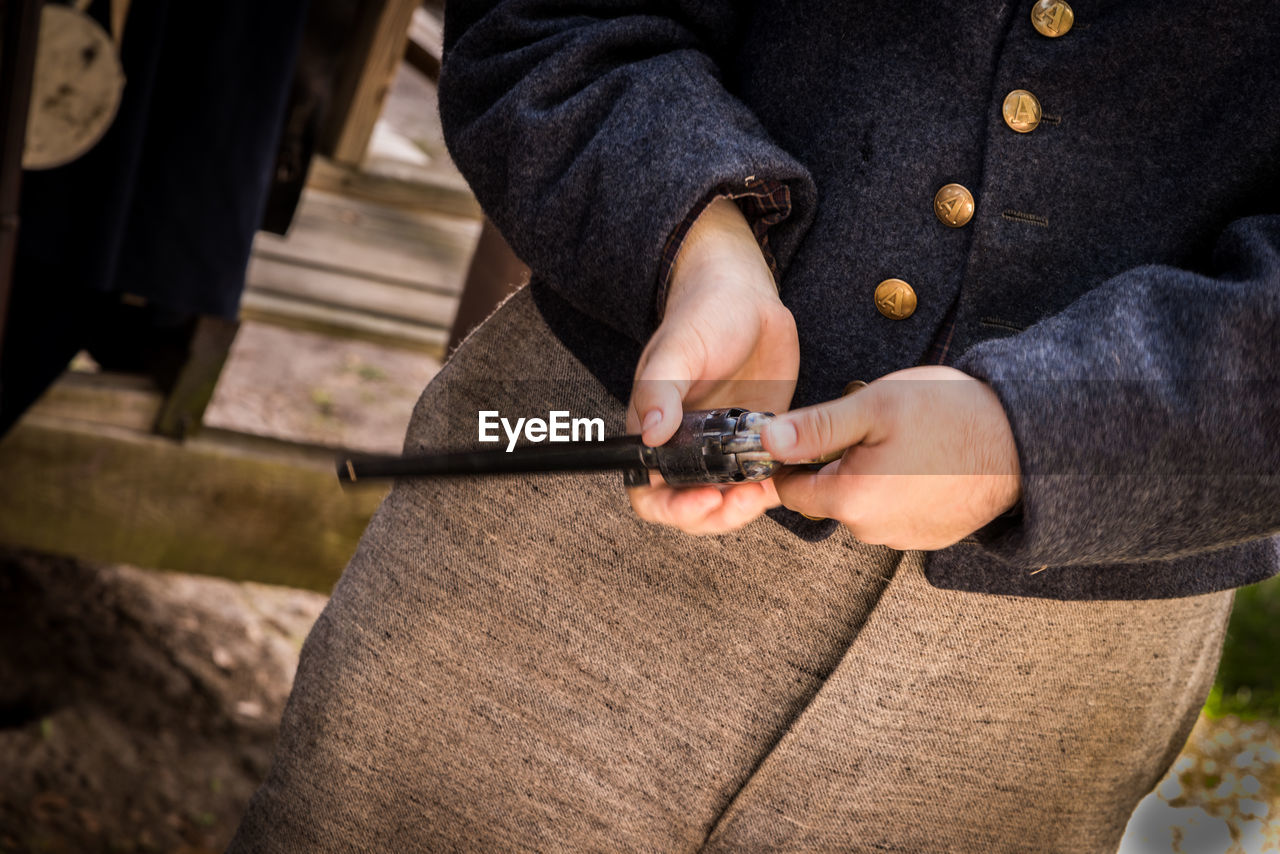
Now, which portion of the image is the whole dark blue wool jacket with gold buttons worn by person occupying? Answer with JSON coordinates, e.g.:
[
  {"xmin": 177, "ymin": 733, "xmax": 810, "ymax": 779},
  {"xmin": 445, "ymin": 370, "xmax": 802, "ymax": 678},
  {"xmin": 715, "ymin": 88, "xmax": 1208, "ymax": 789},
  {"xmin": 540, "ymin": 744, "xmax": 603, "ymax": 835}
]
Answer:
[{"xmin": 440, "ymin": 0, "xmax": 1280, "ymax": 599}]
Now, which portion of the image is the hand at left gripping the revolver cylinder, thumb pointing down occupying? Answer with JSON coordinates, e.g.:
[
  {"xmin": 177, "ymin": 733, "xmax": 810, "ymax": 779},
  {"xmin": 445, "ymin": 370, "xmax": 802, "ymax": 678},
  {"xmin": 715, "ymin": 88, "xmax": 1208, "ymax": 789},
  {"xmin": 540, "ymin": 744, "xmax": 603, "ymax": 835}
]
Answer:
[{"xmin": 627, "ymin": 198, "xmax": 800, "ymax": 534}]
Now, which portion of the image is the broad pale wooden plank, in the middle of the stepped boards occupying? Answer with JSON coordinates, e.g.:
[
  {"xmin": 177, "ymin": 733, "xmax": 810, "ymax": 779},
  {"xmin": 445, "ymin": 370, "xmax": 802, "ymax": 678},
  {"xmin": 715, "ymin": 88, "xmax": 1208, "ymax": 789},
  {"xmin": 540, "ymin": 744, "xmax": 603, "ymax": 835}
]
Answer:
[{"xmin": 253, "ymin": 191, "xmax": 480, "ymax": 293}]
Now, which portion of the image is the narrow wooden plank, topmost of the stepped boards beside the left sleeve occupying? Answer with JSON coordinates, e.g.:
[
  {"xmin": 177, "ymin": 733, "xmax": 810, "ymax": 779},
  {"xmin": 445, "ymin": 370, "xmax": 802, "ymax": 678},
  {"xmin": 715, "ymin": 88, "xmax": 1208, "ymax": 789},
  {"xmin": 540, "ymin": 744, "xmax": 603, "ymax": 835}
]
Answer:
[{"xmin": 307, "ymin": 157, "xmax": 481, "ymax": 219}]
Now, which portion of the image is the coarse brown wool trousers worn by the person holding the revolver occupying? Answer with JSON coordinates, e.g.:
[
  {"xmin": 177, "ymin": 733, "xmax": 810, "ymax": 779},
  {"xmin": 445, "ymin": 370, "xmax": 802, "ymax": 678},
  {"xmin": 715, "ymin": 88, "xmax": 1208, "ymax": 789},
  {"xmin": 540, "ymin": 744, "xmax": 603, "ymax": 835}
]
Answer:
[{"xmin": 230, "ymin": 289, "xmax": 1231, "ymax": 853}]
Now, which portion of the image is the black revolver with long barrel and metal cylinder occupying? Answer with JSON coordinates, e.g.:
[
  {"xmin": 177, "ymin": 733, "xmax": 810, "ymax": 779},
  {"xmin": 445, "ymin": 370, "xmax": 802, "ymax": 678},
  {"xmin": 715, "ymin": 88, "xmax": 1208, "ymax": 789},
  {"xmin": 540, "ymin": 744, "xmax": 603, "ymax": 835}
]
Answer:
[{"xmin": 338, "ymin": 408, "xmax": 782, "ymax": 487}]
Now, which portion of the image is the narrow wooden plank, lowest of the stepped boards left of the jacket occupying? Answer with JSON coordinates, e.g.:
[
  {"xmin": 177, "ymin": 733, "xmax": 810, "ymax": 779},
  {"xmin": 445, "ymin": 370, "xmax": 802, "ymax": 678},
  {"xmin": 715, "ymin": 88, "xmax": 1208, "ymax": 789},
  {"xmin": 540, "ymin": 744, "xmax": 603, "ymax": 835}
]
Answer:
[{"xmin": 241, "ymin": 289, "xmax": 448, "ymax": 359}]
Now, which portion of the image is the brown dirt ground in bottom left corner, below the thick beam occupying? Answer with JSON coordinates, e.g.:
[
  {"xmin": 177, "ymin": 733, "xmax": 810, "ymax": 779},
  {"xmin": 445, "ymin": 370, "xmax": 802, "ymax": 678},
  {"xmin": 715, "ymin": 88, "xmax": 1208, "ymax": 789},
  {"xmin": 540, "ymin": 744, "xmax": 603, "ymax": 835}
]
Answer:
[{"xmin": 0, "ymin": 551, "xmax": 325, "ymax": 854}]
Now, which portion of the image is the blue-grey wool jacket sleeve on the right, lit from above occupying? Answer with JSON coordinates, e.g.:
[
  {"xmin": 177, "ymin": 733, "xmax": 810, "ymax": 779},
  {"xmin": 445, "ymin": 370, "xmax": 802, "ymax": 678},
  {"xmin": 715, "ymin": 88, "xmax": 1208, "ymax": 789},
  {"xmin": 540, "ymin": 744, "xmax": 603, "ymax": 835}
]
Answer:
[{"xmin": 956, "ymin": 216, "xmax": 1280, "ymax": 567}]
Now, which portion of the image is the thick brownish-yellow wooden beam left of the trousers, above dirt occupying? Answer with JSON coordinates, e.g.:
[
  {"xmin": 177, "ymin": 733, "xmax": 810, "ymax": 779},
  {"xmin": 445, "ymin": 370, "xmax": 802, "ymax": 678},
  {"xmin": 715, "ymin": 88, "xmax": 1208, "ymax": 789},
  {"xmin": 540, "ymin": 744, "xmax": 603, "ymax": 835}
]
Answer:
[{"xmin": 0, "ymin": 415, "xmax": 384, "ymax": 592}]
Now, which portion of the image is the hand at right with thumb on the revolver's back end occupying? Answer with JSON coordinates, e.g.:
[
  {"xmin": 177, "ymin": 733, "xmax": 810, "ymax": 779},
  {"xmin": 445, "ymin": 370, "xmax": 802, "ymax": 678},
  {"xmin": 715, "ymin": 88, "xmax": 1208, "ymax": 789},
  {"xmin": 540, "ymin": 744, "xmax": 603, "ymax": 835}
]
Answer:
[{"xmin": 763, "ymin": 366, "xmax": 1021, "ymax": 549}]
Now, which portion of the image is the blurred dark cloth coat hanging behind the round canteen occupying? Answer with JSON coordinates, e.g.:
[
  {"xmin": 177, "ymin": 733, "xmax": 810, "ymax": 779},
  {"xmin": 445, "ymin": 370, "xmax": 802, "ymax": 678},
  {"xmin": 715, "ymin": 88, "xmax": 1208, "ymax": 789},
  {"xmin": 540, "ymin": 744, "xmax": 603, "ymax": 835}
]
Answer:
[{"xmin": 15, "ymin": 0, "xmax": 307, "ymax": 318}]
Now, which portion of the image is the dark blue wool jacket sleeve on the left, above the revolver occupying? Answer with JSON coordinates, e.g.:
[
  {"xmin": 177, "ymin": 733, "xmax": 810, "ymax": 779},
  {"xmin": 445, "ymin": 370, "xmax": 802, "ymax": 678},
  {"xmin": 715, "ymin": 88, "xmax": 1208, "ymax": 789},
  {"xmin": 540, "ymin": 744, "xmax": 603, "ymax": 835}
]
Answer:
[{"xmin": 440, "ymin": 0, "xmax": 815, "ymax": 343}]
